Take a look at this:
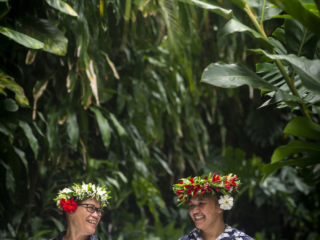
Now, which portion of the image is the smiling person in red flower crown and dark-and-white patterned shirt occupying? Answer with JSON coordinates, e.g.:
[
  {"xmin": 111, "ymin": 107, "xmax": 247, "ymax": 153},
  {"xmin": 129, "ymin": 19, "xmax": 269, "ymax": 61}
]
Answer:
[{"xmin": 173, "ymin": 173, "xmax": 253, "ymax": 240}]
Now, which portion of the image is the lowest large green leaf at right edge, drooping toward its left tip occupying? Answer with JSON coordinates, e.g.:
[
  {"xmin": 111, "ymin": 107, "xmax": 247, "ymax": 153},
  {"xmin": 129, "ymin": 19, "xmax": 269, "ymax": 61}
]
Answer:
[{"xmin": 261, "ymin": 155, "xmax": 320, "ymax": 182}]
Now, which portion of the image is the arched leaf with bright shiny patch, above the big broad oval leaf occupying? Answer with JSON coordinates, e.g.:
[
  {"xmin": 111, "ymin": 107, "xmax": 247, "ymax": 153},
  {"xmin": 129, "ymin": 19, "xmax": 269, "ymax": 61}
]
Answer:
[{"xmin": 219, "ymin": 19, "xmax": 274, "ymax": 51}]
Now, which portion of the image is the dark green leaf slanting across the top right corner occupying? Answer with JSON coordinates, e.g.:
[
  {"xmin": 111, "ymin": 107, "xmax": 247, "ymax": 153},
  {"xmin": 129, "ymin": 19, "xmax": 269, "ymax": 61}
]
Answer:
[{"xmin": 269, "ymin": 0, "xmax": 320, "ymax": 38}]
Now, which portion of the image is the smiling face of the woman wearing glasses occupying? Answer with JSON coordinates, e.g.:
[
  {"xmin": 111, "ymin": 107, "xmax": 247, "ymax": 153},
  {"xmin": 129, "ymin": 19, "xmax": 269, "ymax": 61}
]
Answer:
[{"xmin": 69, "ymin": 198, "xmax": 101, "ymax": 235}]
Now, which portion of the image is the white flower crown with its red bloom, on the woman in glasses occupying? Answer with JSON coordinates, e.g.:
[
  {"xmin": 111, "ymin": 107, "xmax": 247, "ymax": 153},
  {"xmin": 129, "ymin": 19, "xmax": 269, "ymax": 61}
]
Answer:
[{"xmin": 53, "ymin": 183, "xmax": 111, "ymax": 213}]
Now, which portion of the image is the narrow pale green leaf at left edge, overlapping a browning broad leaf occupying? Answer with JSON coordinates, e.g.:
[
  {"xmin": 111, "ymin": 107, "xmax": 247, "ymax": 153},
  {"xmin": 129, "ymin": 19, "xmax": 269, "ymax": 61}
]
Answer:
[{"xmin": 0, "ymin": 26, "xmax": 44, "ymax": 49}]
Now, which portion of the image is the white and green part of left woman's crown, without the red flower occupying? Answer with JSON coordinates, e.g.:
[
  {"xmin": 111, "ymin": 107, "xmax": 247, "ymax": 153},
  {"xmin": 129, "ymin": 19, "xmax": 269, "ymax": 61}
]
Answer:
[{"xmin": 54, "ymin": 183, "xmax": 111, "ymax": 210}]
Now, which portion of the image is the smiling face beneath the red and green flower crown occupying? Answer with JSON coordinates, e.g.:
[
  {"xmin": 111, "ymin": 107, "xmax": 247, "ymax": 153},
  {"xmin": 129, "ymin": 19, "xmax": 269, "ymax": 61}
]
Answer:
[{"xmin": 189, "ymin": 195, "xmax": 223, "ymax": 231}]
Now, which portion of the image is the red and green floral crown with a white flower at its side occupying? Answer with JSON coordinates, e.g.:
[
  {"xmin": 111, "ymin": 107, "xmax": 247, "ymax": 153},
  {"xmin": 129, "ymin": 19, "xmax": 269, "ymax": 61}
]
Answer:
[{"xmin": 173, "ymin": 173, "xmax": 241, "ymax": 210}]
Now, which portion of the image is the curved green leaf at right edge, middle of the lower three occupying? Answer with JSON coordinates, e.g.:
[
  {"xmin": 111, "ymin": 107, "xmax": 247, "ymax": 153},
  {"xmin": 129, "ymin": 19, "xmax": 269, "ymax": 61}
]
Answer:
[{"xmin": 271, "ymin": 140, "xmax": 320, "ymax": 163}]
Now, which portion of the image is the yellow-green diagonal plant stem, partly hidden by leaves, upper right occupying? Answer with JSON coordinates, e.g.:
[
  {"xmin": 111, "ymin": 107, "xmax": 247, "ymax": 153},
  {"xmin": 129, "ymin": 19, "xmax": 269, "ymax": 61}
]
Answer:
[{"xmin": 245, "ymin": 6, "xmax": 310, "ymax": 120}]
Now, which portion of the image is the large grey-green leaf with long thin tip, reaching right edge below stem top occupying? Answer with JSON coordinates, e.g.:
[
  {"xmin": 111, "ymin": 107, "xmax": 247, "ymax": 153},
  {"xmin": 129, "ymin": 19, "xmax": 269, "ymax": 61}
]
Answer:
[{"xmin": 253, "ymin": 49, "xmax": 320, "ymax": 95}]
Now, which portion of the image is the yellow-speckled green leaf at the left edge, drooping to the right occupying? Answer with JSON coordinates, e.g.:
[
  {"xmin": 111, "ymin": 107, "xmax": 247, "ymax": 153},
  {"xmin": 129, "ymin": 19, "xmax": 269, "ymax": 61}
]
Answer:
[{"xmin": 0, "ymin": 69, "xmax": 29, "ymax": 107}]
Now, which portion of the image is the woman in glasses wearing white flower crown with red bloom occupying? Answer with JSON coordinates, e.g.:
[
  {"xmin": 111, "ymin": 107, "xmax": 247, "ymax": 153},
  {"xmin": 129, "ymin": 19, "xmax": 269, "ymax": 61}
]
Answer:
[{"xmin": 50, "ymin": 183, "xmax": 111, "ymax": 240}]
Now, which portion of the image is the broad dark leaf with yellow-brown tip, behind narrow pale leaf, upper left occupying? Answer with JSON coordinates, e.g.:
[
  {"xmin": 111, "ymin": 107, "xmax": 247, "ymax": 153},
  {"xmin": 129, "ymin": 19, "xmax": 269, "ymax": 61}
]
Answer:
[{"xmin": 17, "ymin": 16, "xmax": 68, "ymax": 56}]
